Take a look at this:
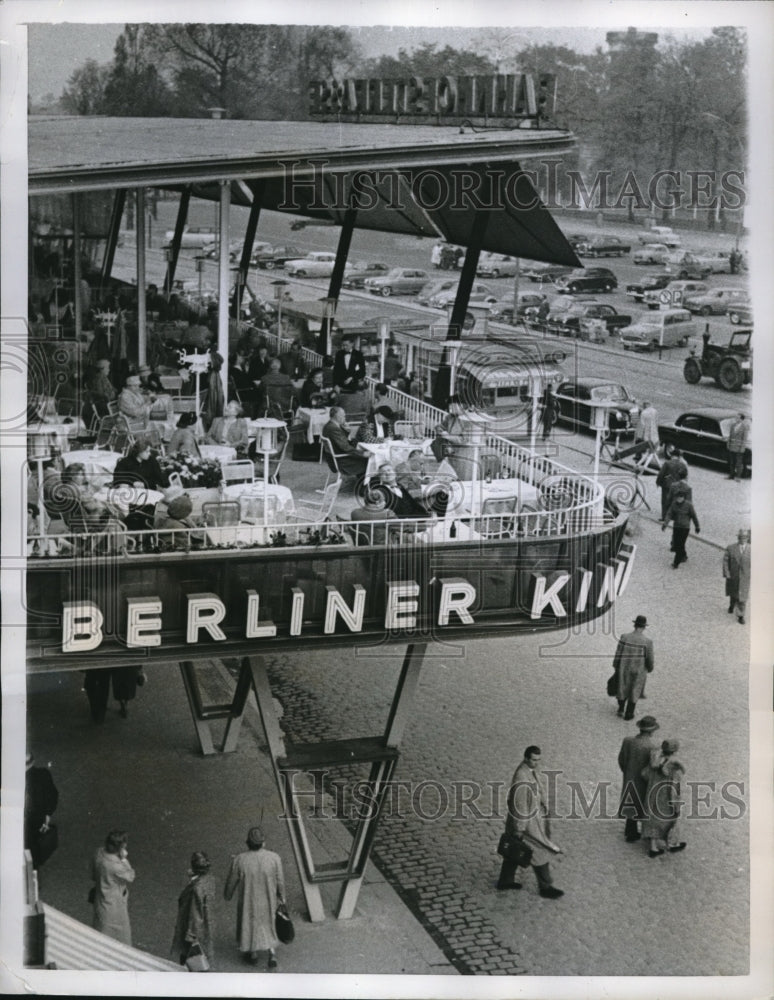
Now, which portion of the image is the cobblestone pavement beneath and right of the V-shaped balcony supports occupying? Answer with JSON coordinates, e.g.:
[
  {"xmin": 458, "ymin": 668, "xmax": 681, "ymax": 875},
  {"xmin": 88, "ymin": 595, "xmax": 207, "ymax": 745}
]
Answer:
[{"xmin": 260, "ymin": 504, "xmax": 749, "ymax": 976}]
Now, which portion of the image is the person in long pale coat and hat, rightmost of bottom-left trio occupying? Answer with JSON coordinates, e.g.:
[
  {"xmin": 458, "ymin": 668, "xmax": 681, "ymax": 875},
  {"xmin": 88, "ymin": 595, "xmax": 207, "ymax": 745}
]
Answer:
[{"xmin": 223, "ymin": 826, "xmax": 285, "ymax": 969}]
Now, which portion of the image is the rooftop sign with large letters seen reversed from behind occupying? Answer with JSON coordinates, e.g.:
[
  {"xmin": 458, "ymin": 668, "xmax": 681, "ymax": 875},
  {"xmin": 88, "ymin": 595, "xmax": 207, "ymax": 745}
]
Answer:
[{"xmin": 309, "ymin": 73, "xmax": 556, "ymax": 123}]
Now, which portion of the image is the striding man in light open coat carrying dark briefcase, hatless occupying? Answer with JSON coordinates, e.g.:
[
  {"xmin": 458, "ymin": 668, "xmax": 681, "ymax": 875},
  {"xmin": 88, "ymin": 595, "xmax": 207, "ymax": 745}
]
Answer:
[{"xmin": 497, "ymin": 746, "xmax": 564, "ymax": 899}]
